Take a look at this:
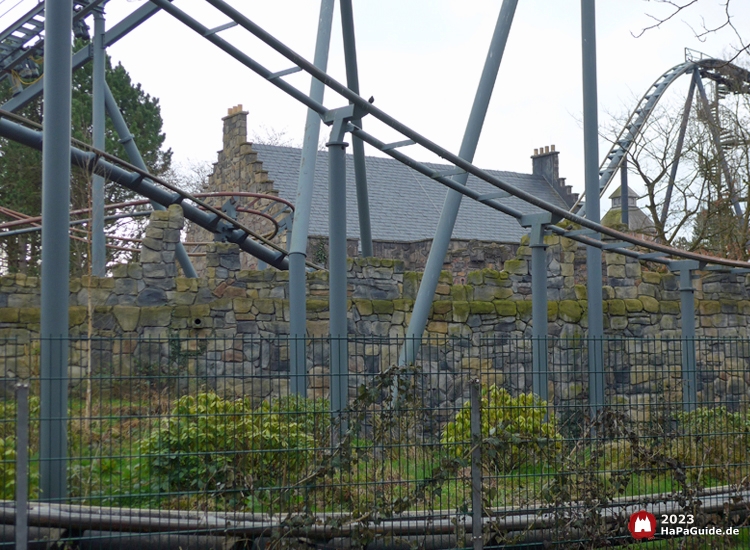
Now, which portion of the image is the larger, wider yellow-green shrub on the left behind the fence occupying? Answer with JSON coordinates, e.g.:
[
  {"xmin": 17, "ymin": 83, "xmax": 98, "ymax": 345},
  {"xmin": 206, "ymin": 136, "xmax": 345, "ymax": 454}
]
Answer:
[{"xmin": 141, "ymin": 392, "xmax": 322, "ymax": 500}]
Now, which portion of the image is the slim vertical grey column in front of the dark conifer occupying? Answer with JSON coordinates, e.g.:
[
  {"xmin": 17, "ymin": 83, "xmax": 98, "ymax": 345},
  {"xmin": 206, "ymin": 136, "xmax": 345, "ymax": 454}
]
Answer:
[{"xmin": 91, "ymin": 8, "xmax": 107, "ymax": 277}]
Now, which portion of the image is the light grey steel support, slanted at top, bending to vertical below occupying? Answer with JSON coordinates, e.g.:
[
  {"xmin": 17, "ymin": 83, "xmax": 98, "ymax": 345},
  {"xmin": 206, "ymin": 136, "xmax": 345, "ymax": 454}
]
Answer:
[{"xmin": 289, "ymin": 0, "xmax": 334, "ymax": 396}]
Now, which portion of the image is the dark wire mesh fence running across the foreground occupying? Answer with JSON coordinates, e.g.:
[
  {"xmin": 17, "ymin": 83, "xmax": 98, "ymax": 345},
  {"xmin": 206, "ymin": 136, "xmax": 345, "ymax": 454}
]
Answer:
[{"xmin": 0, "ymin": 336, "xmax": 750, "ymax": 548}]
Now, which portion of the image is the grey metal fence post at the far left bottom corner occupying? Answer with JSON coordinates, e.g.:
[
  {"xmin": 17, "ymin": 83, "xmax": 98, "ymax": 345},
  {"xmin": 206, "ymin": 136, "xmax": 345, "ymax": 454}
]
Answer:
[{"xmin": 16, "ymin": 382, "xmax": 29, "ymax": 548}]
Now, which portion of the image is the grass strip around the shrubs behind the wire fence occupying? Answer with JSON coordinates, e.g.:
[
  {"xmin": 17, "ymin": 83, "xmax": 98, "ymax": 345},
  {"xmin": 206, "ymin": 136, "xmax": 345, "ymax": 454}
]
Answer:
[{"xmin": 0, "ymin": 384, "xmax": 747, "ymax": 528}]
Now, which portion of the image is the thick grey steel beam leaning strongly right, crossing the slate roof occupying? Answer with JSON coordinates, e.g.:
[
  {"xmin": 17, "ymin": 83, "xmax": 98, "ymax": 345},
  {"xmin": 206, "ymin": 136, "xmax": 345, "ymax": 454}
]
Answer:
[{"xmin": 399, "ymin": 0, "xmax": 518, "ymax": 365}]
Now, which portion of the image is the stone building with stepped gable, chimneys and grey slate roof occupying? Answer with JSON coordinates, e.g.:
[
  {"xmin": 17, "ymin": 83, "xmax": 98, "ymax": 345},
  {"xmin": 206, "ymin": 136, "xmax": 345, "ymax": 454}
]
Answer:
[{"xmin": 187, "ymin": 106, "xmax": 577, "ymax": 282}]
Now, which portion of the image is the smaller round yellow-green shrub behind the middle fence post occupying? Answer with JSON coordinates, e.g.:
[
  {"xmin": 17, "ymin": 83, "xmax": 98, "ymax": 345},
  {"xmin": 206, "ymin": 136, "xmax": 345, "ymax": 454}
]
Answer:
[{"xmin": 441, "ymin": 385, "xmax": 562, "ymax": 473}]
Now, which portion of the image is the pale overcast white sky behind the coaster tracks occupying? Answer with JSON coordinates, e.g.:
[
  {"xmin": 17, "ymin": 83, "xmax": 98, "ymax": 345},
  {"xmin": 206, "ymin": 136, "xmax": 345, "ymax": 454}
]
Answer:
[{"xmin": 5, "ymin": 0, "xmax": 750, "ymax": 203}]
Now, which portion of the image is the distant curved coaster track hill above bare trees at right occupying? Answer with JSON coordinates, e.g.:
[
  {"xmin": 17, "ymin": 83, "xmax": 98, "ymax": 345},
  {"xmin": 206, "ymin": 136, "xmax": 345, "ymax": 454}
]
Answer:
[{"xmin": 571, "ymin": 58, "xmax": 750, "ymax": 211}]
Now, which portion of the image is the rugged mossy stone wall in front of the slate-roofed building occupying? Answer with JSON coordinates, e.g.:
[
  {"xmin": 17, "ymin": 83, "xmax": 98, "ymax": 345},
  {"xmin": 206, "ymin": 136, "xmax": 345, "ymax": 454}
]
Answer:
[{"xmin": 0, "ymin": 206, "xmax": 750, "ymax": 414}]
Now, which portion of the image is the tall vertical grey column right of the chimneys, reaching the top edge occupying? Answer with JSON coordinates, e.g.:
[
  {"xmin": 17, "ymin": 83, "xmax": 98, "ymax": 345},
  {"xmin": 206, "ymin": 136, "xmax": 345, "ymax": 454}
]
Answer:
[{"xmin": 581, "ymin": 0, "xmax": 604, "ymax": 417}]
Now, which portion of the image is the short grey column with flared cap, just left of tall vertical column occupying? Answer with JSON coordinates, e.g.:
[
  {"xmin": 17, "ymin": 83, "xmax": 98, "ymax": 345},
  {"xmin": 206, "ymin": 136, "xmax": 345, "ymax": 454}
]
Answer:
[{"xmin": 520, "ymin": 212, "xmax": 552, "ymax": 401}]
